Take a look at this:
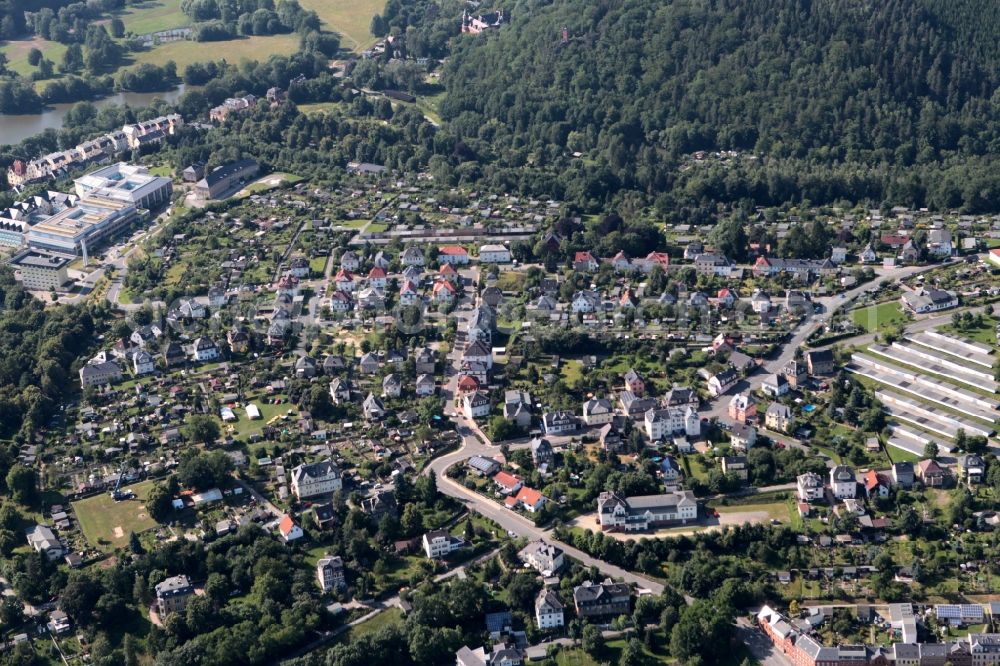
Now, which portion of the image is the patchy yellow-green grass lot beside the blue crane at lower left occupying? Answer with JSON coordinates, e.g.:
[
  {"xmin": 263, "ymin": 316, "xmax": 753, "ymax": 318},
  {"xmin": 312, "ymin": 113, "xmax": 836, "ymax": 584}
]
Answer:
[{"xmin": 73, "ymin": 481, "xmax": 156, "ymax": 551}]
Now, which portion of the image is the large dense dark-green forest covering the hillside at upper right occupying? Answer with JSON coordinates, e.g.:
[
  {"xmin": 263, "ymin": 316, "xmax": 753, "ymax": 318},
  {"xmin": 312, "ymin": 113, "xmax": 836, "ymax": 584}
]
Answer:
[{"xmin": 432, "ymin": 0, "xmax": 1000, "ymax": 211}]
